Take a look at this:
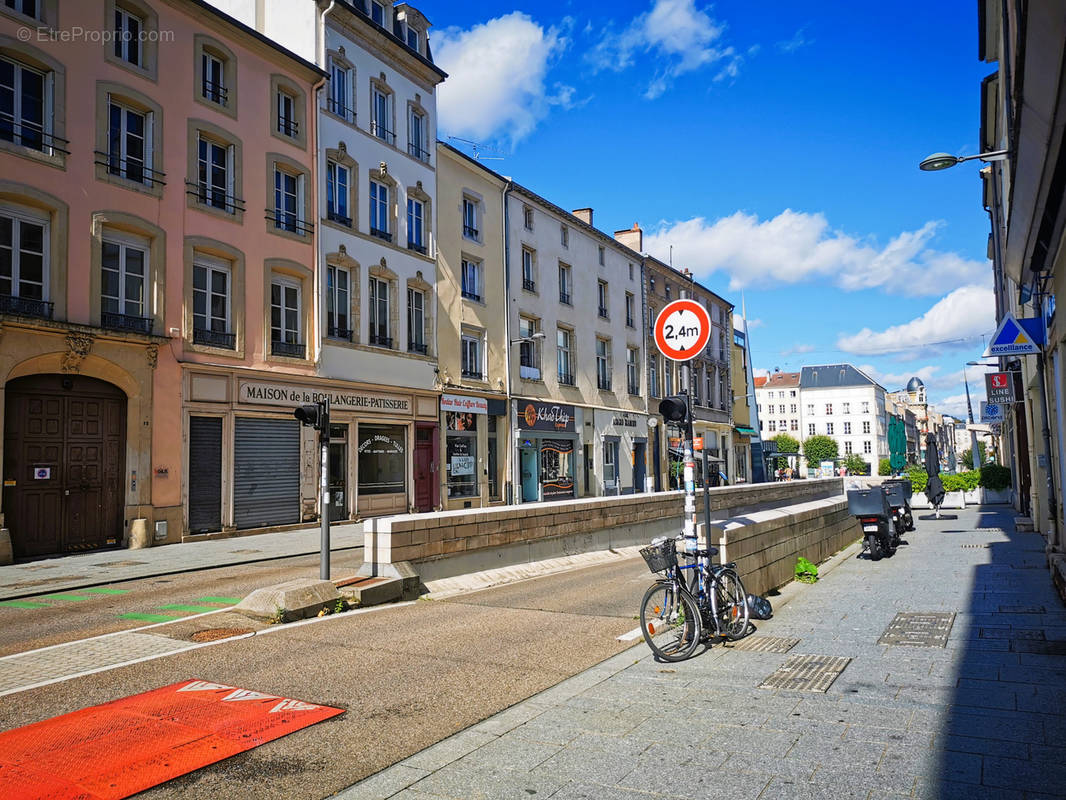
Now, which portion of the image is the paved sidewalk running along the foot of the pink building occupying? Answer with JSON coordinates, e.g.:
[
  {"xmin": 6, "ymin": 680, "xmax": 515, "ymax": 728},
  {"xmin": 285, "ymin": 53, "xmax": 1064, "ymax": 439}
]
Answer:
[{"xmin": 0, "ymin": 524, "xmax": 362, "ymax": 599}]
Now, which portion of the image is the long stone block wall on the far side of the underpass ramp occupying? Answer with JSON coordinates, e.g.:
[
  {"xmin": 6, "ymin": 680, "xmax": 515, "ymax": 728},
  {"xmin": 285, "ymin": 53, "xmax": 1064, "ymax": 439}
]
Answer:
[{"xmin": 364, "ymin": 478, "xmax": 842, "ymax": 581}]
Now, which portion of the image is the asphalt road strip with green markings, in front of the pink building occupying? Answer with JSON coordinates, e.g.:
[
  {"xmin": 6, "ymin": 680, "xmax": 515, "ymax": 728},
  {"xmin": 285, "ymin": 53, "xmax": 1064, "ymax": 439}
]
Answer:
[{"xmin": 0, "ymin": 547, "xmax": 362, "ymax": 656}]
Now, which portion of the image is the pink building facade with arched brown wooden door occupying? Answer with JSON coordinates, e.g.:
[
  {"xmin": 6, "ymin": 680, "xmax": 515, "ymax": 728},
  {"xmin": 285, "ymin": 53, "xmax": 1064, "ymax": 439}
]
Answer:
[{"xmin": 0, "ymin": 0, "xmax": 325, "ymax": 558}]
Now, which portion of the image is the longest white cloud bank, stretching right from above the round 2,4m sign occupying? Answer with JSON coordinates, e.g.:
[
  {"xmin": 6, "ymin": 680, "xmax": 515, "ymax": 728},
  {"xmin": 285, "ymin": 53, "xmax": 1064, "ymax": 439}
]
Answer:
[{"xmin": 644, "ymin": 209, "xmax": 991, "ymax": 294}]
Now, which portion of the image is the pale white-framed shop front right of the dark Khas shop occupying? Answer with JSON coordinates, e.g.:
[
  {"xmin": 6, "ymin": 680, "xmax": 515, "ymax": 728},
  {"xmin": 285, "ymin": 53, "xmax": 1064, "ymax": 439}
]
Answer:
[{"xmin": 586, "ymin": 409, "xmax": 648, "ymax": 495}]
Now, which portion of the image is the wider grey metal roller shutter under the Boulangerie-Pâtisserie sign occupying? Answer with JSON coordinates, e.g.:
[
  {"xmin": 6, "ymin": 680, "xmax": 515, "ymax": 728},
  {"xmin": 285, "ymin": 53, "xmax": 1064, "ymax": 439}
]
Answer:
[{"xmin": 233, "ymin": 417, "xmax": 300, "ymax": 528}]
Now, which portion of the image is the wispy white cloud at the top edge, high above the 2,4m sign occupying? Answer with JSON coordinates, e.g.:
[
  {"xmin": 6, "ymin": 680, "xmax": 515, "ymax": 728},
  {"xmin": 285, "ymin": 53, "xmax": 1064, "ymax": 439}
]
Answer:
[{"xmin": 588, "ymin": 0, "xmax": 750, "ymax": 100}]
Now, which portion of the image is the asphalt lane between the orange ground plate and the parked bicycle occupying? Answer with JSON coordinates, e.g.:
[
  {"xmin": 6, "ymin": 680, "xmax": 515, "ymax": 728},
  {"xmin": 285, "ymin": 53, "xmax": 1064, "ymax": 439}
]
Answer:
[{"xmin": 0, "ymin": 558, "xmax": 651, "ymax": 800}]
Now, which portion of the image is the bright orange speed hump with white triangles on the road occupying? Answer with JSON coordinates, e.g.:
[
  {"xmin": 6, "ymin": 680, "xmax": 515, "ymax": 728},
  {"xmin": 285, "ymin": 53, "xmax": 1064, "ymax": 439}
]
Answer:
[{"xmin": 0, "ymin": 681, "xmax": 344, "ymax": 800}]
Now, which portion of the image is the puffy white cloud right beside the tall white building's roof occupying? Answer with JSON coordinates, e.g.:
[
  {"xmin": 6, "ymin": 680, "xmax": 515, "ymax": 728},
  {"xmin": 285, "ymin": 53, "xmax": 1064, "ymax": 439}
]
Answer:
[{"xmin": 433, "ymin": 11, "xmax": 575, "ymax": 144}]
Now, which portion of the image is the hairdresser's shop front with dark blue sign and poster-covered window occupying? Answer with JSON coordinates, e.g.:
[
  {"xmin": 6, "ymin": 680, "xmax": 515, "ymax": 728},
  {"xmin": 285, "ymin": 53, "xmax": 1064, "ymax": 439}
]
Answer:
[{"xmin": 440, "ymin": 395, "xmax": 507, "ymax": 509}]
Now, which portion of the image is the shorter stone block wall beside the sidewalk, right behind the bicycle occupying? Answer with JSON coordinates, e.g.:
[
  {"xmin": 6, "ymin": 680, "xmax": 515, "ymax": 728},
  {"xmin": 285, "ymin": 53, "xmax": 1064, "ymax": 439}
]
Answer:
[{"xmin": 710, "ymin": 495, "xmax": 862, "ymax": 594}]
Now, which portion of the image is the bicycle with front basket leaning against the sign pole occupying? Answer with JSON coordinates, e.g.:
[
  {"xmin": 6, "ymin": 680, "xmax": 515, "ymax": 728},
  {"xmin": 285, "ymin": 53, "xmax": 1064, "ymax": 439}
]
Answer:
[{"xmin": 641, "ymin": 537, "xmax": 749, "ymax": 661}]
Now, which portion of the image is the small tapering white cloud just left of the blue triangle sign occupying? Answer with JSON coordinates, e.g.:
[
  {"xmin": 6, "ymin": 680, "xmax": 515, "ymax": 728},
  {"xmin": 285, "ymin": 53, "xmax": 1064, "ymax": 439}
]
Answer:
[{"xmin": 837, "ymin": 286, "xmax": 996, "ymax": 358}]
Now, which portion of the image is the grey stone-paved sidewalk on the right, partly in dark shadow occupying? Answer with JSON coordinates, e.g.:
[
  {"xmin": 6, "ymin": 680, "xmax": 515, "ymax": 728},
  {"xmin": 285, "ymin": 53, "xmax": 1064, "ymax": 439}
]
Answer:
[{"xmin": 338, "ymin": 507, "xmax": 1066, "ymax": 800}]
